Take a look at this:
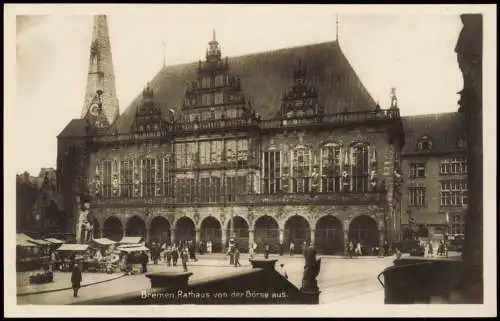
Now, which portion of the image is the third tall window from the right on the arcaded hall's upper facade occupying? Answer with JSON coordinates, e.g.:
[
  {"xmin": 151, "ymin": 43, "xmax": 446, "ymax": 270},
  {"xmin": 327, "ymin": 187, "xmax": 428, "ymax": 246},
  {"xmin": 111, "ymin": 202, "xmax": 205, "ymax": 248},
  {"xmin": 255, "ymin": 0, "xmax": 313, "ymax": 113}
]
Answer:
[{"xmin": 292, "ymin": 147, "xmax": 311, "ymax": 193}]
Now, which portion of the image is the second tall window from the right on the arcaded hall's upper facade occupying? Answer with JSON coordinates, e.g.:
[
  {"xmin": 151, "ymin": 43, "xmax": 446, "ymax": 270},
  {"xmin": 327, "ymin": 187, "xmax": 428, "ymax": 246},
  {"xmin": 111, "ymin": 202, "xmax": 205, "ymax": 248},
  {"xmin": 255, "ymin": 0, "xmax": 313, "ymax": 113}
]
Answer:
[{"xmin": 321, "ymin": 144, "xmax": 341, "ymax": 192}]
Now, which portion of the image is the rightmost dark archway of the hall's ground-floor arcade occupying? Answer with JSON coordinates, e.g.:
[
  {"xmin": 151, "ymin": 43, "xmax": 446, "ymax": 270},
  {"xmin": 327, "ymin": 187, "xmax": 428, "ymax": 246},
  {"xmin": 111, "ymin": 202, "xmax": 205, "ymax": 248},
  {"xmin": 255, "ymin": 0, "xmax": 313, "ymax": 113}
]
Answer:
[{"xmin": 349, "ymin": 215, "xmax": 379, "ymax": 254}]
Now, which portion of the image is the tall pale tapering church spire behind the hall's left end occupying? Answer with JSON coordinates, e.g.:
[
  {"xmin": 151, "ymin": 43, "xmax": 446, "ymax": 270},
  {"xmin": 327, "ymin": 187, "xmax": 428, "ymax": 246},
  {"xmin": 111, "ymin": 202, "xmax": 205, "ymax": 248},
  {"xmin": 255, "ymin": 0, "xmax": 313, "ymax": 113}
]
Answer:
[{"xmin": 82, "ymin": 15, "xmax": 120, "ymax": 128}]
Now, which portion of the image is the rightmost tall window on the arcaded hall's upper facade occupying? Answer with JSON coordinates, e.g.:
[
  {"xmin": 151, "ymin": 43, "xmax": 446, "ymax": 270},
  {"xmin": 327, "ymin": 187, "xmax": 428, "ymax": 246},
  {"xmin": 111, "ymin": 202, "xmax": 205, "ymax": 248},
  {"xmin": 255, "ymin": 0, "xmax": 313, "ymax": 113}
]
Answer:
[{"xmin": 351, "ymin": 144, "xmax": 370, "ymax": 192}]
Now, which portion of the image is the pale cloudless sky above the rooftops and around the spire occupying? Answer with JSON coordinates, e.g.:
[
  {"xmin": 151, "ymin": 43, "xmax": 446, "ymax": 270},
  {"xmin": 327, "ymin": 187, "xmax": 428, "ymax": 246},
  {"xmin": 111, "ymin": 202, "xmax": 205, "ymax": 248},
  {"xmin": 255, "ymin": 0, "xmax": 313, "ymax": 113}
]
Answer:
[{"xmin": 14, "ymin": 5, "xmax": 472, "ymax": 174}]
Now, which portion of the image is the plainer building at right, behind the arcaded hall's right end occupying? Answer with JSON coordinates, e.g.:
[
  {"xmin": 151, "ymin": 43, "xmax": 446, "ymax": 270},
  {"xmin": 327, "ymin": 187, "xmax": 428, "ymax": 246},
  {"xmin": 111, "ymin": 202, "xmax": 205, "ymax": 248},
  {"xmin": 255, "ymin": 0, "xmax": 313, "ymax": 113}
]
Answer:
[{"xmin": 401, "ymin": 113, "xmax": 468, "ymax": 241}]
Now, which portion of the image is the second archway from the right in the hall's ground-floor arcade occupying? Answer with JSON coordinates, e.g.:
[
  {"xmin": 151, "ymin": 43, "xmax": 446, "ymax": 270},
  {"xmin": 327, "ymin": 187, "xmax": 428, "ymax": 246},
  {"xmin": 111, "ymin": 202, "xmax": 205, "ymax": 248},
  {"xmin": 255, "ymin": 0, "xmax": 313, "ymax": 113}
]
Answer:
[{"xmin": 315, "ymin": 215, "xmax": 344, "ymax": 255}]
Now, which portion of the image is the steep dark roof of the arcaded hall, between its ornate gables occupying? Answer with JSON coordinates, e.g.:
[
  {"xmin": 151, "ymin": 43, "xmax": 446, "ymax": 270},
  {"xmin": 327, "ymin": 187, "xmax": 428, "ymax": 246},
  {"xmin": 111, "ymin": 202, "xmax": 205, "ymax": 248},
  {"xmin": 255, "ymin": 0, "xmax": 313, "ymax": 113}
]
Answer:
[{"xmin": 110, "ymin": 41, "xmax": 376, "ymax": 133}]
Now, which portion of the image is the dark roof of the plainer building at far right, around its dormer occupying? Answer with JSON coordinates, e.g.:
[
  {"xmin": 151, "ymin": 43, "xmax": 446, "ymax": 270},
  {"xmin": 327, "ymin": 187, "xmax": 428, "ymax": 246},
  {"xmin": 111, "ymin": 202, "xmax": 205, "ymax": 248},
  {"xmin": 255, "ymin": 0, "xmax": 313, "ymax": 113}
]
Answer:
[{"xmin": 402, "ymin": 112, "xmax": 464, "ymax": 155}]
